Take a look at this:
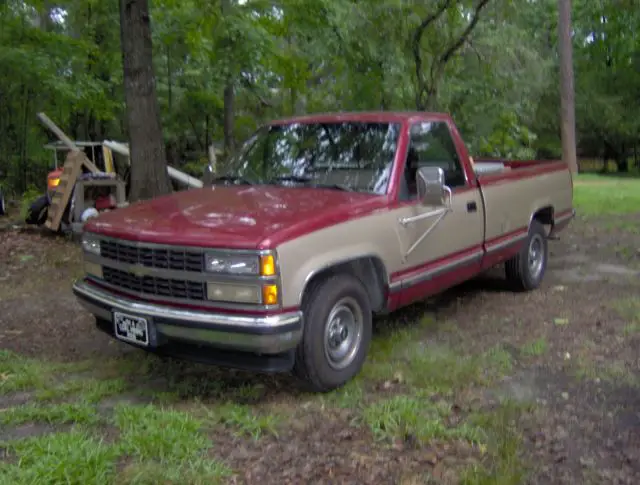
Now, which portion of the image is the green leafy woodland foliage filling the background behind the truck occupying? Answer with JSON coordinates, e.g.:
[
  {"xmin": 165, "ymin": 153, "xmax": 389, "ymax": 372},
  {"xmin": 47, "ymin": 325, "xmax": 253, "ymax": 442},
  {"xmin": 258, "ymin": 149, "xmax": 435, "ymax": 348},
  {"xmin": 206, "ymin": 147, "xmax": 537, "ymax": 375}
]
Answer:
[{"xmin": 0, "ymin": 0, "xmax": 640, "ymax": 197}]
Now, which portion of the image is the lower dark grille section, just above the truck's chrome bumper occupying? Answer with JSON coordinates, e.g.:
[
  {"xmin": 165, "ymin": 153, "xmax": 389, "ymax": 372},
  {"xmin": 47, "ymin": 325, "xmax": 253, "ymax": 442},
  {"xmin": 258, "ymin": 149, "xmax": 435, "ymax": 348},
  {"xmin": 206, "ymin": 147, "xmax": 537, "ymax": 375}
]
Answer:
[{"xmin": 102, "ymin": 266, "xmax": 206, "ymax": 300}]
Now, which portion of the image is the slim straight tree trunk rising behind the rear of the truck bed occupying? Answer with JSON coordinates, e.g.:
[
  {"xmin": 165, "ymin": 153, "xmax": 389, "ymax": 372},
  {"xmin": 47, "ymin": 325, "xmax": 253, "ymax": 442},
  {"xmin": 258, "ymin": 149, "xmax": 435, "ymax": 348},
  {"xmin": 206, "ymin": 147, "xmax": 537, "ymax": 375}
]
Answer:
[{"xmin": 558, "ymin": 0, "xmax": 578, "ymax": 173}]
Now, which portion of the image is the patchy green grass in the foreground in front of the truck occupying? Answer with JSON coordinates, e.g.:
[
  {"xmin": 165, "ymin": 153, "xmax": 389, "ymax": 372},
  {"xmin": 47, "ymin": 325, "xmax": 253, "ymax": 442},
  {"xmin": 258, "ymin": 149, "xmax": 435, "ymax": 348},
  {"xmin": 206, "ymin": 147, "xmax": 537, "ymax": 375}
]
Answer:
[{"xmin": 0, "ymin": 318, "xmax": 519, "ymax": 485}]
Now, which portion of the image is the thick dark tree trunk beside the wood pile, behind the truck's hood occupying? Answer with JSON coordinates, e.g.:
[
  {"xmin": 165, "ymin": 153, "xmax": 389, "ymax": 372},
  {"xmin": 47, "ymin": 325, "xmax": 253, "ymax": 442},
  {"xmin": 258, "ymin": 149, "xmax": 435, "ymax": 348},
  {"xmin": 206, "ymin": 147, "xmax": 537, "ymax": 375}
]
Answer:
[{"xmin": 120, "ymin": 0, "xmax": 171, "ymax": 202}]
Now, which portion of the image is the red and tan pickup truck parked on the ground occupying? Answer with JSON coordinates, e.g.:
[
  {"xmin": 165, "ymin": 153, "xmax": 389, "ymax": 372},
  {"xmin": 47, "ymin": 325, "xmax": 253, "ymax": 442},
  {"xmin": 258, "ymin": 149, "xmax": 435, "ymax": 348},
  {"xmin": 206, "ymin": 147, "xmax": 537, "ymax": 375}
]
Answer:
[{"xmin": 73, "ymin": 112, "xmax": 575, "ymax": 391}]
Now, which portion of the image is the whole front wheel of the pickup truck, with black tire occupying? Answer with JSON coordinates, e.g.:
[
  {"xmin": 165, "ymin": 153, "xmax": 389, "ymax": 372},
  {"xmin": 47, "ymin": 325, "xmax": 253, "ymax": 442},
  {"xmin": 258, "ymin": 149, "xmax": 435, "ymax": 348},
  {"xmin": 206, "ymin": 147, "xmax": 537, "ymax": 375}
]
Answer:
[{"xmin": 294, "ymin": 274, "xmax": 372, "ymax": 392}]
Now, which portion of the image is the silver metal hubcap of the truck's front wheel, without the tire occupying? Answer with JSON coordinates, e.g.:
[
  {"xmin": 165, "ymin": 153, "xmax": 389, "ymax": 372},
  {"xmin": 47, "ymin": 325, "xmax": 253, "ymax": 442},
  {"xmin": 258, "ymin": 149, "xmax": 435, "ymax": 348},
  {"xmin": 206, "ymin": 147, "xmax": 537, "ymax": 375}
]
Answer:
[{"xmin": 324, "ymin": 297, "xmax": 363, "ymax": 370}]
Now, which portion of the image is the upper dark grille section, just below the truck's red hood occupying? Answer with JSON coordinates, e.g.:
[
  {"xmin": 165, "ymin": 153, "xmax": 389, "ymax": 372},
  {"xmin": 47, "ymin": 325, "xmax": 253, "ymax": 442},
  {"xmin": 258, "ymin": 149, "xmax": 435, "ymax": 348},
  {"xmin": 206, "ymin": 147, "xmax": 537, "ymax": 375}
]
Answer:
[{"xmin": 100, "ymin": 240, "xmax": 204, "ymax": 272}]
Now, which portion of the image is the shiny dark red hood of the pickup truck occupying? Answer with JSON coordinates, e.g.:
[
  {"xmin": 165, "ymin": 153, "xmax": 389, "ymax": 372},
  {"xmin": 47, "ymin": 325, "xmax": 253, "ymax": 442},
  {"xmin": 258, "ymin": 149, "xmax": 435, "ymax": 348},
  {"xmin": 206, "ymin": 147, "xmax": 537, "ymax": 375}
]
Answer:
[{"xmin": 85, "ymin": 185, "xmax": 386, "ymax": 249}]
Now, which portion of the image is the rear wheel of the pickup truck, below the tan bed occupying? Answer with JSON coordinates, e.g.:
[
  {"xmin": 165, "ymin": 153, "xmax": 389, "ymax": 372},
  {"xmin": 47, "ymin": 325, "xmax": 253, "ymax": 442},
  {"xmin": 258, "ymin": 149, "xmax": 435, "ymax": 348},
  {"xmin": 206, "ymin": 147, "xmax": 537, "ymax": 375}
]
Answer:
[{"xmin": 505, "ymin": 219, "xmax": 549, "ymax": 291}]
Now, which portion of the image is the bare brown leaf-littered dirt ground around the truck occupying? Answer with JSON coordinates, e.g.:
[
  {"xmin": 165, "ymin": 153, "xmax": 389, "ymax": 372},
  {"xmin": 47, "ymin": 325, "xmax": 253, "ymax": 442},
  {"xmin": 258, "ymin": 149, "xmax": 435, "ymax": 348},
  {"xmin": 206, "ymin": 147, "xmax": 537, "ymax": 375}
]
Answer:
[{"xmin": 0, "ymin": 215, "xmax": 640, "ymax": 484}]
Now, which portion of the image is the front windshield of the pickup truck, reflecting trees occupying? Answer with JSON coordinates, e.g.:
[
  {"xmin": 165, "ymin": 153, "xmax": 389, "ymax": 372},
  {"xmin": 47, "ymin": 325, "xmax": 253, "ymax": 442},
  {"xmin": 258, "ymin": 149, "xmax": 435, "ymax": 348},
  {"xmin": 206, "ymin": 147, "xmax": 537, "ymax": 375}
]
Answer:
[{"xmin": 222, "ymin": 121, "xmax": 400, "ymax": 194}]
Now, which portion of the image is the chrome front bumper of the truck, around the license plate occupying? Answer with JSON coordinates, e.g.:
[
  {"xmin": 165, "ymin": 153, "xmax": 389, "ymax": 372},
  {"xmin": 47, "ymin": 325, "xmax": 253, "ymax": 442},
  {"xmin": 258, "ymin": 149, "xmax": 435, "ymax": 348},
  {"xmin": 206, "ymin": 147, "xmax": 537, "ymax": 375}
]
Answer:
[{"xmin": 73, "ymin": 281, "xmax": 302, "ymax": 354}]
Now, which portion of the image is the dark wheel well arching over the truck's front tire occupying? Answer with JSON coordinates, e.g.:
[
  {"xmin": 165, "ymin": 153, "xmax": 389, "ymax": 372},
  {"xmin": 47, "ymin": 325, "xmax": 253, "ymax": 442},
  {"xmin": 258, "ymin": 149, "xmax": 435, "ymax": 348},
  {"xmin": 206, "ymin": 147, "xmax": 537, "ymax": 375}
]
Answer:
[{"xmin": 302, "ymin": 256, "xmax": 387, "ymax": 312}]
